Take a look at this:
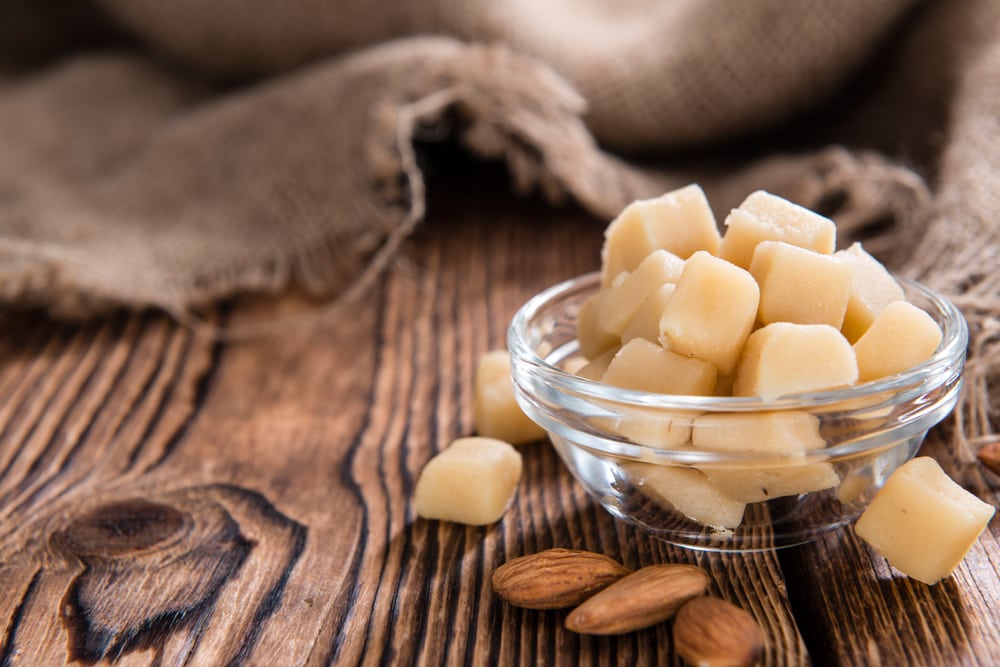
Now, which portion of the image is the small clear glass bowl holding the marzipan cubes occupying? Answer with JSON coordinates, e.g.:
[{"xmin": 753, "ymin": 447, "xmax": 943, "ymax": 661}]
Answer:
[{"xmin": 507, "ymin": 273, "xmax": 968, "ymax": 551}]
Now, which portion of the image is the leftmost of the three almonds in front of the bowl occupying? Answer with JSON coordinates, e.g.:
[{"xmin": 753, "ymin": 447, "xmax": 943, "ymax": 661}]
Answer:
[{"xmin": 493, "ymin": 549, "xmax": 631, "ymax": 609}]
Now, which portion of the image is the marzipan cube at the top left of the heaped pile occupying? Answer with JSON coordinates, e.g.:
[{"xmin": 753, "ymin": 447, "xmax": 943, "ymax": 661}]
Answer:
[{"xmin": 601, "ymin": 185, "xmax": 719, "ymax": 287}]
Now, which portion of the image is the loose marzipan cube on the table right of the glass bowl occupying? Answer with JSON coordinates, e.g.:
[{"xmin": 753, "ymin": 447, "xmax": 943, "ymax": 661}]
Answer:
[{"xmin": 854, "ymin": 456, "xmax": 995, "ymax": 584}]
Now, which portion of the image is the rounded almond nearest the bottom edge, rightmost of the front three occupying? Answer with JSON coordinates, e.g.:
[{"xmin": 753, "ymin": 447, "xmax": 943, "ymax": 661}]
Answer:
[{"xmin": 674, "ymin": 597, "xmax": 764, "ymax": 667}]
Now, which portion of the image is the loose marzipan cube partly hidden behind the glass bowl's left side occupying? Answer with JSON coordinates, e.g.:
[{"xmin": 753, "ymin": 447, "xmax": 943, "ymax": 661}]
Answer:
[{"xmin": 473, "ymin": 350, "xmax": 545, "ymax": 444}]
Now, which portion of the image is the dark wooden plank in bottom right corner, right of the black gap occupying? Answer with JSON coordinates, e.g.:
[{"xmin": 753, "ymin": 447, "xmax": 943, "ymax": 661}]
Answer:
[{"xmin": 780, "ymin": 430, "xmax": 1000, "ymax": 666}]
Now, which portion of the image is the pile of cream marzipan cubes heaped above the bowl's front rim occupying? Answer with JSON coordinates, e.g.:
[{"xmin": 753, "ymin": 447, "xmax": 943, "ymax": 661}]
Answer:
[{"xmin": 577, "ymin": 185, "xmax": 941, "ymax": 400}]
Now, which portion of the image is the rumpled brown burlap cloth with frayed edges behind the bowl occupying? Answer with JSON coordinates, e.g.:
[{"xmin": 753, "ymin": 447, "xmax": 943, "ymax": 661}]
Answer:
[{"xmin": 0, "ymin": 0, "xmax": 1000, "ymax": 453}]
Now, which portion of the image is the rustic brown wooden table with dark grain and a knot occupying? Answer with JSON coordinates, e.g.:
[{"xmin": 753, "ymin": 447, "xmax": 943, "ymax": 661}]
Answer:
[{"xmin": 0, "ymin": 153, "xmax": 1000, "ymax": 665}]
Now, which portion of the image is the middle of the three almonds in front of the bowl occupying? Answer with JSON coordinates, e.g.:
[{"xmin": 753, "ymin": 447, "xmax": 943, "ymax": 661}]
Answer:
[{"xmin": 566, "ymin": 564, "xmax": 708, "ymax": 635}]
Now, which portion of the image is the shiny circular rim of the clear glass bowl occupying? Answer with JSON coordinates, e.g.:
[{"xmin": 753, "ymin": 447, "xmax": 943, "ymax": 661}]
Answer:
[{"xmin": 507, "ymin": 271, "xmax": 969, "ymax": 412}]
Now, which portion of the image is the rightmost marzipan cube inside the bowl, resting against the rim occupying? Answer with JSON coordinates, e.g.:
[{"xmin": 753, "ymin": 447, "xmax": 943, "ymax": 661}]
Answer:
[{"xmin": 854, "ymin": 301, "xmax": 941, "ymax": 382}]
